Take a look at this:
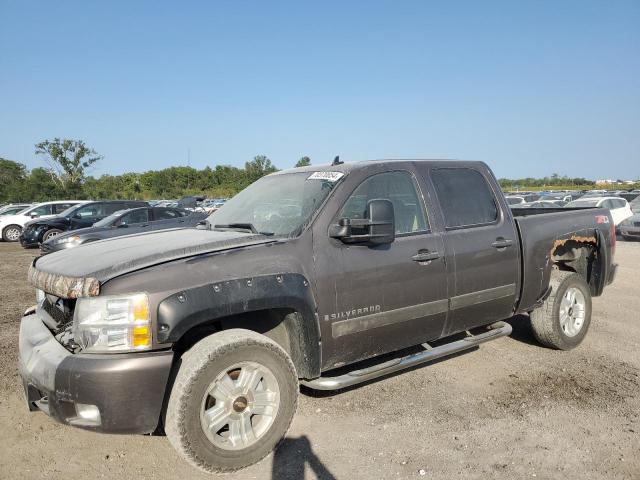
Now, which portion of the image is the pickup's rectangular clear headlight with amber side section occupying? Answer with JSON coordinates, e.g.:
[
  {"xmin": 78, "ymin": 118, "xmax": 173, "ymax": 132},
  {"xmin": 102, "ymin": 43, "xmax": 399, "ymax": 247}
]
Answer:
[{"xmin": 73, "ymin": 293, "xmax": 151, "ymax": 353}]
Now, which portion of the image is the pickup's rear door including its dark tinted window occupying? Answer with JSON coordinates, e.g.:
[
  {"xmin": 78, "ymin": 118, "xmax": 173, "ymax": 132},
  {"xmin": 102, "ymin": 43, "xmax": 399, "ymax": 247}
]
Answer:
[{"xmin": 428, "ymin": 167, "xmax": 520, "ymax": 334}]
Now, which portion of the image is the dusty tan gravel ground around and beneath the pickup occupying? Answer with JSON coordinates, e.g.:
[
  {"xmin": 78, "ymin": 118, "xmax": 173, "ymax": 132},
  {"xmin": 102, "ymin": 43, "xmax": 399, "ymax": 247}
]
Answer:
[{"xmin": 0, "ymin": 242, "xmax": 640, "ymax": 480}]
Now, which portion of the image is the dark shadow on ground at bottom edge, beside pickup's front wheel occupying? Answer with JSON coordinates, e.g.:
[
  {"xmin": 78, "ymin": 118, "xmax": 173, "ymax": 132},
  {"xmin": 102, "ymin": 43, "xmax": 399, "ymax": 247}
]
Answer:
[{"xmin": 271, "ymin": 435, "xmax": 336, "ymax": 480}]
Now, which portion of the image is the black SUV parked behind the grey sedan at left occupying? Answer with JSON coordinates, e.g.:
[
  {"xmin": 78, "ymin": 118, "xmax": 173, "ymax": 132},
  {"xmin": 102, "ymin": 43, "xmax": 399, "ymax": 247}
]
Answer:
[{"xmin": 20, "ymin": 200, "xmax": 148, "ymax": 248}]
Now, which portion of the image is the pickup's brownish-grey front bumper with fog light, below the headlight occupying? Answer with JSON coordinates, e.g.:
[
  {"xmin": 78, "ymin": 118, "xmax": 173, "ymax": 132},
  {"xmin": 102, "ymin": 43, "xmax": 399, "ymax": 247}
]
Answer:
[{"xmin": 19, "ymin": 309, "xmax": 173, "ymax": 433}]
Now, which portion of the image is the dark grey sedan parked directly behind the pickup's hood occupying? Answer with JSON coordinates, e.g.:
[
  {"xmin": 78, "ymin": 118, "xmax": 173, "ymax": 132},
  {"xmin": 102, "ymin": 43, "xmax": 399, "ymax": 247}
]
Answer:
[{"xmin": 40, "ymin": 207, "xmax": 207, "ymax": 254}]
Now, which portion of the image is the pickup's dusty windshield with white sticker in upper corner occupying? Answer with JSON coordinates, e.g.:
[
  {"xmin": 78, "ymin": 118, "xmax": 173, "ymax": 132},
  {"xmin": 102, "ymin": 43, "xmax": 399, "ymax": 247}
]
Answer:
[{"xmin": 207, "ymin": 171, "xmax": 343, "ymax": 236}]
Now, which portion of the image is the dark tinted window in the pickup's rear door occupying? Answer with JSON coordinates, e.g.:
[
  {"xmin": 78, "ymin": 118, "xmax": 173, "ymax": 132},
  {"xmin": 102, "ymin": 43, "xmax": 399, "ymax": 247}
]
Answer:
[{"xmin": 431, "ymin": 168, "xmax": 498, "ymax": 228}]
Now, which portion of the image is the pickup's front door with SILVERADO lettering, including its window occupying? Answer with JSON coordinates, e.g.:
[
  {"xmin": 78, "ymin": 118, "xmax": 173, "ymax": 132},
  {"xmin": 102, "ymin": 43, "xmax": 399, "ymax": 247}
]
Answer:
[{"xmin": 314, "ymin": 170, "xmax": 448, "ymax": 369}]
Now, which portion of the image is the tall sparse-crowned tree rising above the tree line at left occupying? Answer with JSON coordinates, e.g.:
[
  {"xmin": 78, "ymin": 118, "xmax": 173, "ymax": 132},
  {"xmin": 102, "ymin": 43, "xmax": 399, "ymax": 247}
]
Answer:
[{"xmin": 36, "ymin": 138, "xmax": 103, "ymax": 195}]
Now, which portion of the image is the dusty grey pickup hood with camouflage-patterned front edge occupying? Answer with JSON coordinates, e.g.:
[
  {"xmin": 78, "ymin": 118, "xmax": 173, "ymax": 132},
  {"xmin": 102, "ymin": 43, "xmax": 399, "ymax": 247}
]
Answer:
[{"xmin": 29, "ymin": 228, "xmax": 278, "ymax": 298}]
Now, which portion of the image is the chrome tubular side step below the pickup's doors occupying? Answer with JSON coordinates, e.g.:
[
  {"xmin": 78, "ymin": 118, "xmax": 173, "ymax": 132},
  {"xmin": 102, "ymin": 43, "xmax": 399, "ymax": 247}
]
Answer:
[{"xmin": 300, "ymin": 322, "xmax": 512, "ymax": 390}]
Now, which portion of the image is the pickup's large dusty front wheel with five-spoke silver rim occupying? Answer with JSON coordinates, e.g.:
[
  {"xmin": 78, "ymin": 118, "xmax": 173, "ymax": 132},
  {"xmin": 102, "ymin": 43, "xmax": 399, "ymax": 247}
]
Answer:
[{"xmin": 164, "ymin": 329, "xmax": 299, "ymax": 473}]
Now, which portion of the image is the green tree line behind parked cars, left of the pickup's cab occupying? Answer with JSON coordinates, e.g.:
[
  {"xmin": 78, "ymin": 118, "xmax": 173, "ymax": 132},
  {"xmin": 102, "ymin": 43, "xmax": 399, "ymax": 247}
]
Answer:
[{"xmin": 0, "ymin": 138, "xmax": 311, "ymax": 203}]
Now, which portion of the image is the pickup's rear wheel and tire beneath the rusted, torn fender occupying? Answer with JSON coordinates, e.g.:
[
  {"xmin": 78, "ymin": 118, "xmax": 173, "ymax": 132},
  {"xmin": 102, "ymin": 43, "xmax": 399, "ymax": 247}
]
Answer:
[{"xmin": 530, "ymin": 270, "xmax": 591, "ymax": 350}]
